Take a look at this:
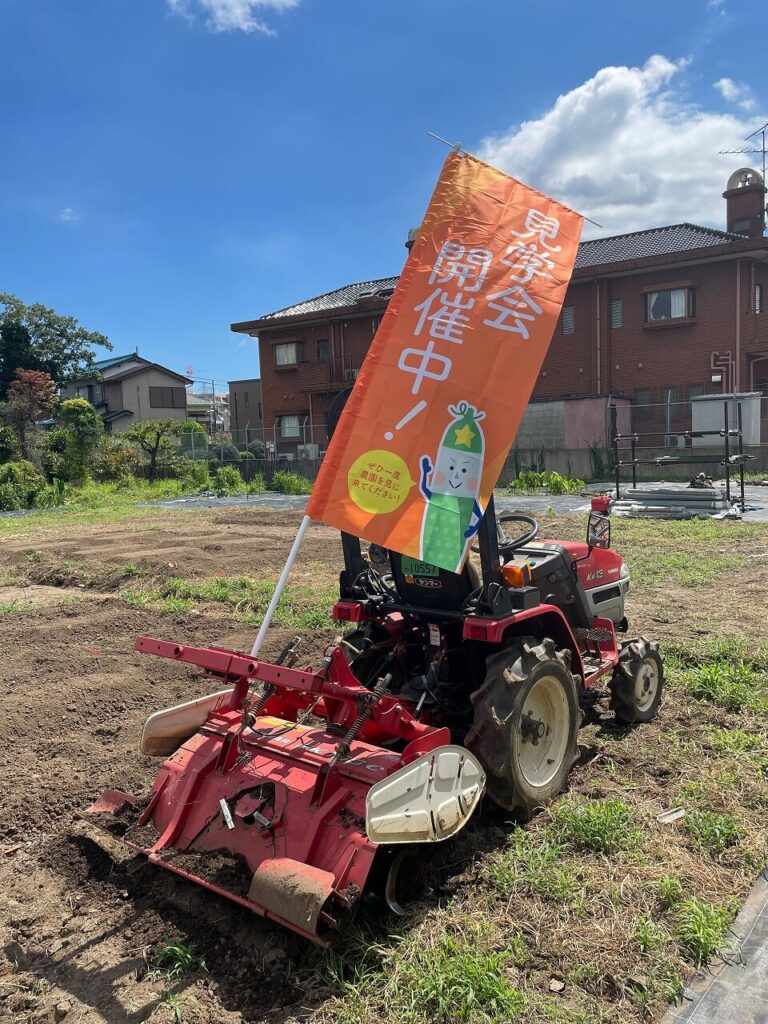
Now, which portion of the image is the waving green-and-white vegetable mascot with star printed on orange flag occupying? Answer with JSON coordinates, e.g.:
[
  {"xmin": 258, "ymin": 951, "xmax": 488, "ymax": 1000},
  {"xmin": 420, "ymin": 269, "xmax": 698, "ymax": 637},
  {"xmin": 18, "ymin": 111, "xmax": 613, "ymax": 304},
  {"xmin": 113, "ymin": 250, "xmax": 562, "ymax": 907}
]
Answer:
[{"xmin": 419, "ymin": 401, "xmax": 485, "ymax": 572}]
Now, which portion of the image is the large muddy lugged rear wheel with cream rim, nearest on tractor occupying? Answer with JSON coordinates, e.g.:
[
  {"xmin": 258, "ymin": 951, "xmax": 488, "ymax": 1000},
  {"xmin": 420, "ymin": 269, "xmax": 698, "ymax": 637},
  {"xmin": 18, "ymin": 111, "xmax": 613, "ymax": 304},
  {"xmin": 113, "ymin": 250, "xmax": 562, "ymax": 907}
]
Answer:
[{"xmin": 465, "ymin": 638, "xmax": 582, "ymax": 820}]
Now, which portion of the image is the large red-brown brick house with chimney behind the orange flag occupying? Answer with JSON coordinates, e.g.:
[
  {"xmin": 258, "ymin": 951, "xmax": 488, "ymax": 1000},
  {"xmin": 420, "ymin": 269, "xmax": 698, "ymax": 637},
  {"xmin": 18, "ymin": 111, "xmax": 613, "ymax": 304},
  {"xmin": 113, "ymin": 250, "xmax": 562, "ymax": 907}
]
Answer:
[{"xmin": 231, "ymin": 169, "xmax": 768, "ymax": 451}]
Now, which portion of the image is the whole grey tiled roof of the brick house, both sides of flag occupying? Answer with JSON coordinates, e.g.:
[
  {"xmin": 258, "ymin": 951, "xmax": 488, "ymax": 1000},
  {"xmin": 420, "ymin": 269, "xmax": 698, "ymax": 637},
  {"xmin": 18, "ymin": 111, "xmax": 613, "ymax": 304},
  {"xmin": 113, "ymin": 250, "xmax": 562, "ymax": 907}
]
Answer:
[{"xmin": 252, "ymin": 224, "xmax": 745, "ymax": 322}]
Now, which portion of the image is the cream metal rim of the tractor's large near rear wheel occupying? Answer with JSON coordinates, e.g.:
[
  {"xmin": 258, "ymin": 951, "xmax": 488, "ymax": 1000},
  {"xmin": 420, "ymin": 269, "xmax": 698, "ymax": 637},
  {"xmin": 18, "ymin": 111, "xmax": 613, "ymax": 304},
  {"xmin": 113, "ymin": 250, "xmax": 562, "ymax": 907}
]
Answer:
[{"xmin": 516, "ymin": 676, "xmax": 570, "ymax": 788}]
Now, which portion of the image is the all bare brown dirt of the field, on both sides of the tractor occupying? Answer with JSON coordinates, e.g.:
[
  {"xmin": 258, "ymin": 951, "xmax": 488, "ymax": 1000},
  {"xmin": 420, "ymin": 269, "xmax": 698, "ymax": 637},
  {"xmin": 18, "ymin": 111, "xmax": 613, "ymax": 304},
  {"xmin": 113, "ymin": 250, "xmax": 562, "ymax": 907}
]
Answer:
[{"xmin": 0, "ymin": 509, "xmax": 768, "ymax": 1024}]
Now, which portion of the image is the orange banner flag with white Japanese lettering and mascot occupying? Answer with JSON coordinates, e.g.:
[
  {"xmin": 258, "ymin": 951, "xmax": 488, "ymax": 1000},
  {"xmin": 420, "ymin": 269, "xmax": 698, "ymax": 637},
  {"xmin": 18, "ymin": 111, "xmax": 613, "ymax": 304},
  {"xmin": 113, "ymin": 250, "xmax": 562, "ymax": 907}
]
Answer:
[{"xmin": 307, "ymin": 153, "xmax": 583, "ymax": 572}]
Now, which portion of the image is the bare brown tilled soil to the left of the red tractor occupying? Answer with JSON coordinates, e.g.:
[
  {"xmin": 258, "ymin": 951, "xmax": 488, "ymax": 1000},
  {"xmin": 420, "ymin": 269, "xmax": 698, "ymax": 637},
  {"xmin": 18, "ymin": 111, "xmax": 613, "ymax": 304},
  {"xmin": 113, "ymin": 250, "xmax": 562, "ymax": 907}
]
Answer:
[{"xmin": 0, "ymin": 510, "xmax": 340, "ymax": 1024}]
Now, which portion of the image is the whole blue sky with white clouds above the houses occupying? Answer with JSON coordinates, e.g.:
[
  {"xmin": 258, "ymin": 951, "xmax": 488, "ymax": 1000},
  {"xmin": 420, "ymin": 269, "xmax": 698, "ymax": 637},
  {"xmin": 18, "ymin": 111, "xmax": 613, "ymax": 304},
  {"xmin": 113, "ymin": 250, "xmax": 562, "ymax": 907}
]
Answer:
[{"xmin": 0, "ymin": 0, "xmax": 768, "ymax": 381}]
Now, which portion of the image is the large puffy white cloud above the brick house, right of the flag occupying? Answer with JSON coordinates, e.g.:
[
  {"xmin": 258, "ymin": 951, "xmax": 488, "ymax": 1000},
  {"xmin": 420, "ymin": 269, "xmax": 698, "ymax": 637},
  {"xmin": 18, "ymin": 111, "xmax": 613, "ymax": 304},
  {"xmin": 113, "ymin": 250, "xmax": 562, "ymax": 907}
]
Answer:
[{"xmin": 478, "ymin": 54, "xmax": 752, "ymax": 236}]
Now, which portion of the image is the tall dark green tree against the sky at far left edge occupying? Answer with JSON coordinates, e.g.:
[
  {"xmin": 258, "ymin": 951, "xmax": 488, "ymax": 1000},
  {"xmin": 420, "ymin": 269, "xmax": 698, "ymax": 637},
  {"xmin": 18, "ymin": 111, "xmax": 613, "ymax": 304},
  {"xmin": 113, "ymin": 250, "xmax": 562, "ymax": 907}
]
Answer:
[{"xmin": 0, "ymin": 292, "xmax": 112, "ymax": 399}]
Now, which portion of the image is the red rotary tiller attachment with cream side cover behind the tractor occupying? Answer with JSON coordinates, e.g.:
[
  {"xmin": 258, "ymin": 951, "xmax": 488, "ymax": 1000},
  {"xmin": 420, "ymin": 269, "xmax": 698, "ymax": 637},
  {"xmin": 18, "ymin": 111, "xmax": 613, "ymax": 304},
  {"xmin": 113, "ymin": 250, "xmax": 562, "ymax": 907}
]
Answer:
[{"xmin": 81, "ymin": 637, "xmax": 485, "ymax": 941}]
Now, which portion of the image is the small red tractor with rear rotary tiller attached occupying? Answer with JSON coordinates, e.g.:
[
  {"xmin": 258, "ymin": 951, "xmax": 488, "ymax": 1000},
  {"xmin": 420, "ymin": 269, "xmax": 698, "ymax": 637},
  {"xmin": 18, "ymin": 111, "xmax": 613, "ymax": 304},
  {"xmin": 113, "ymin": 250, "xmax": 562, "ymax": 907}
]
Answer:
[{"xmin": 82, "ymin": 501, "xmax": 664, "ymax": 941}]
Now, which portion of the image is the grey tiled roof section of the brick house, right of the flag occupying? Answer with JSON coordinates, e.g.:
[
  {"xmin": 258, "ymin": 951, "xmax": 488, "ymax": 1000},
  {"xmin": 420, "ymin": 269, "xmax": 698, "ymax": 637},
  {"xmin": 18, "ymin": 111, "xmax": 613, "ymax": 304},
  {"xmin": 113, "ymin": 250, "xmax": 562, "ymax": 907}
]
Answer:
[{"xmin": 575, "ymin": 224, "xmax": 744, "ymax": 270}]
